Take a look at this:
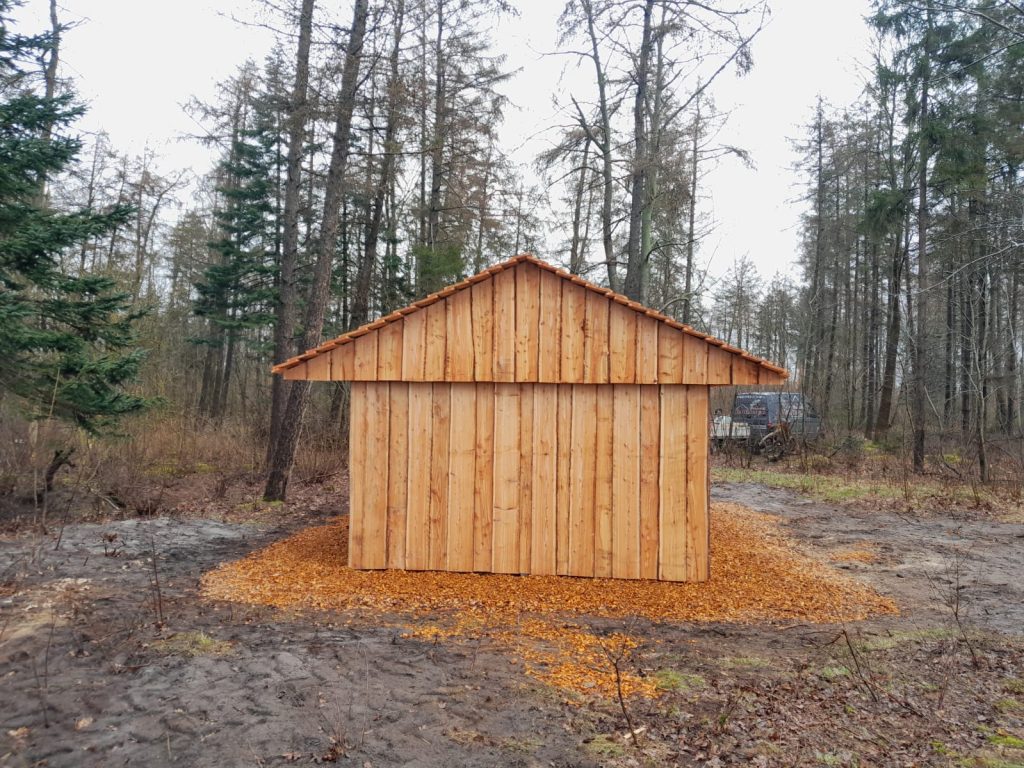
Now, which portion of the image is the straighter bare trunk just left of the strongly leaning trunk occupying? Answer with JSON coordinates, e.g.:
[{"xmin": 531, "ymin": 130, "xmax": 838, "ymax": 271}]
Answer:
[{"xmin": 266, "ymin": 0, "xmax": 315, "ymax": 466}]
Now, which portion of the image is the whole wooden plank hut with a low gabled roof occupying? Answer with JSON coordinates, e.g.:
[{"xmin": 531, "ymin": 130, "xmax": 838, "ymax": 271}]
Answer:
[{"xmin": 274, "ymin": 254, "xmax": 786, "ymax": 582}]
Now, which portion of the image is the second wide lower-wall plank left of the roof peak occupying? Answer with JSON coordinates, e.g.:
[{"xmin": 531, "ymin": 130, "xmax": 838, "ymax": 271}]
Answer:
[{"xmin": 445, "ymin": 385, "xmax": 476, "ymax": 571}]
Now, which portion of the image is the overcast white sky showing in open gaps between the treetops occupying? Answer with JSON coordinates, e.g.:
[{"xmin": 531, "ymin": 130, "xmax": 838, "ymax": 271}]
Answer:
[{"xmin": 19, "ymin": 0, "xmax": 869, "ymax": 276}]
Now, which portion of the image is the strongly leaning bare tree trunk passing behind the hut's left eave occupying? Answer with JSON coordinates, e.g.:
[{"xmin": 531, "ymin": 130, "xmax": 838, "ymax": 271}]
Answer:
[{"xmin": 263, "ymin": 0, "xmax": 368, "ymax": 501}]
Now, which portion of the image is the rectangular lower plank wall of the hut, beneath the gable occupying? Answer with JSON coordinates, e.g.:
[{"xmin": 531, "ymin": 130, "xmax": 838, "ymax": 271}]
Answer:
[{"xmin": 349, "ymin": 378, "xmax": 709, "ymax": 581}]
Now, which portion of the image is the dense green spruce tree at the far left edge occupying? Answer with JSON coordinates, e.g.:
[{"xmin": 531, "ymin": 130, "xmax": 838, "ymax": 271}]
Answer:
[{"xmin": 0, "ymin": 0, "xmax": 145, "ymax": 433}]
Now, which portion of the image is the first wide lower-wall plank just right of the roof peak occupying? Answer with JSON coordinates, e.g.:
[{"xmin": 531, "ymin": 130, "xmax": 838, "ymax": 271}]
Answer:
[{"xmin": 529, "ymin": 384, "xmax": 558, "ymax": 575}]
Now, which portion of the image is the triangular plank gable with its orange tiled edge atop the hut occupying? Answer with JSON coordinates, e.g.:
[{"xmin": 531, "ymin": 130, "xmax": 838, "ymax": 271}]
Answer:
[{"xmin": 273, "ymin": 254, "xmax": 788, "ymax": 385}]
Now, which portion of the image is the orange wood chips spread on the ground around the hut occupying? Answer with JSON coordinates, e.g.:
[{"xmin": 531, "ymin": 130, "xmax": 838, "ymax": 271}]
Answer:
[{"xmin": 203, "ymin": 504, "xmax": 897, "ymax": 696}]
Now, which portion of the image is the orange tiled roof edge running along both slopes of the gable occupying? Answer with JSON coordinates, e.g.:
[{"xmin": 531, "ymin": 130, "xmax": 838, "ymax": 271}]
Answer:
[{"xmin": 271, "ymin": 252, "xmax": 788, "ymax": 374}]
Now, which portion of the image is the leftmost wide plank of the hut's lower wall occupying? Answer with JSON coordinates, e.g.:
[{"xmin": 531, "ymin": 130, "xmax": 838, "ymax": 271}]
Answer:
[{"xmin": 360, "ymin": 381, "xmax": 390, "ymax": 568}]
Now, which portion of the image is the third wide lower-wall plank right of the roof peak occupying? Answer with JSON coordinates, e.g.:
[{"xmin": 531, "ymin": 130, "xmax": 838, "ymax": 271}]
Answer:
[{"xmin": 611, "ymin": 384, "xmax": 640, "ymax": 579}]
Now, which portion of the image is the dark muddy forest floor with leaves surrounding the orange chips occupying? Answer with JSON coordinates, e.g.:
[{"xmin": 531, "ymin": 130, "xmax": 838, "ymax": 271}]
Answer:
[{"xmin": 0, "ymin": 477, "xmax": 1024, "ymax": 768}]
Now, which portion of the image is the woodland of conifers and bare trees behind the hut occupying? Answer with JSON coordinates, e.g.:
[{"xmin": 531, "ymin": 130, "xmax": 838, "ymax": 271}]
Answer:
[{"xmin": 0, "ymin": 0, "xmax": 1024, "ymax": 514}]
